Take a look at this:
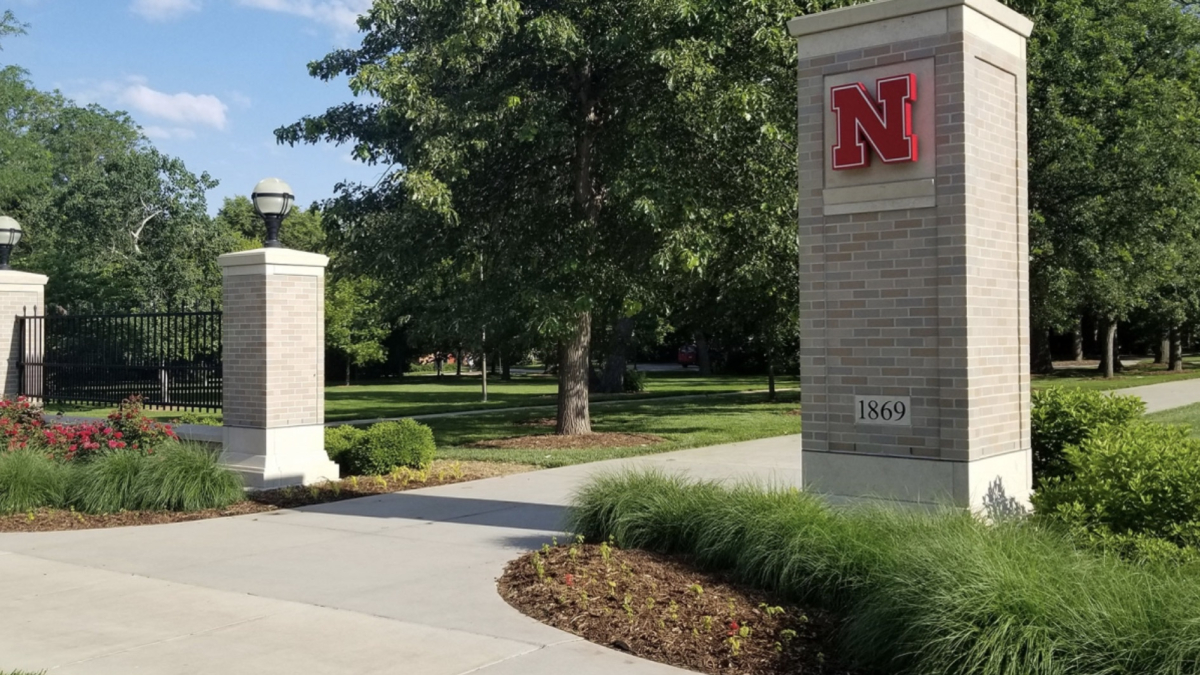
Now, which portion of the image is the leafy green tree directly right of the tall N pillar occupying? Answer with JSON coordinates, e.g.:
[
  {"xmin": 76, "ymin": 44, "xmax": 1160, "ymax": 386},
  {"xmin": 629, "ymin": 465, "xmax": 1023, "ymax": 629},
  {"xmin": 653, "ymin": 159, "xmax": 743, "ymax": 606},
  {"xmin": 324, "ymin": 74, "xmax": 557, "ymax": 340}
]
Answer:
[{"xmin": 1015, "ymin": 0, "xmax": 1200, "ymax": 377}]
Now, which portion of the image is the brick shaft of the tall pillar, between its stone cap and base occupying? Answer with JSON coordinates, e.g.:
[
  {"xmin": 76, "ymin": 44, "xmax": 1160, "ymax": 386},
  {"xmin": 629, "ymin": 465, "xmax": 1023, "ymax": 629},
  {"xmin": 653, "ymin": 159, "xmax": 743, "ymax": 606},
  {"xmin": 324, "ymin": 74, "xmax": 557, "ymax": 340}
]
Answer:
[{"xmin": 799, "ymin": 22, "xmax": 1028, "ymax": 461}]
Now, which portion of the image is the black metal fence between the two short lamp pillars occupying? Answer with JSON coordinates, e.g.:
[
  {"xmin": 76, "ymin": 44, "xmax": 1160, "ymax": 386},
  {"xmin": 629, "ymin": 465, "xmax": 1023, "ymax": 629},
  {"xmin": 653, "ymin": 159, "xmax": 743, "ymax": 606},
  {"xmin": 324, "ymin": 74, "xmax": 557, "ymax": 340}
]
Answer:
[{"xmin": 17, "ymin": 307, "xmax": 222, "ymax": 411}]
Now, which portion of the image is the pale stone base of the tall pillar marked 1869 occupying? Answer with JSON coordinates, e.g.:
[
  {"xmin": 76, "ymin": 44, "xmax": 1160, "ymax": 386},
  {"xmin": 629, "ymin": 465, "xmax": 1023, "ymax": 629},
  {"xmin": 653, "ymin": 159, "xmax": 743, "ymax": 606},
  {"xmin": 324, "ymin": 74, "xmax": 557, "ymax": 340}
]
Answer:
[{"xmin": 802, "ymin": 450, "xmax": 1033, "ymax": 516}]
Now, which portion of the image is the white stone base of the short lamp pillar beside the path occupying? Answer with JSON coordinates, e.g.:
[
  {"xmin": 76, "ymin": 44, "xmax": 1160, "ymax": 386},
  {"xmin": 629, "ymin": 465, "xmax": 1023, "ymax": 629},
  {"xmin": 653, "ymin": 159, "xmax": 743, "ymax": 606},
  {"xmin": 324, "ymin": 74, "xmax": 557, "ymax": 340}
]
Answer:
[{"xmin": 221, "ymin": 424, "xmax": 338, "ymax": 490}]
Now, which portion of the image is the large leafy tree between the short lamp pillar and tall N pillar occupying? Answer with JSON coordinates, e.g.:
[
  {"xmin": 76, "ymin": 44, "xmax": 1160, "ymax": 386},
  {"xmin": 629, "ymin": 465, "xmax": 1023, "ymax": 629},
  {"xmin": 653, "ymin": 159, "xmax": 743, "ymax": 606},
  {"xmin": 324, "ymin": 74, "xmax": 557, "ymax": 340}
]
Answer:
[{"xmin": 277, "ymin": 0, "xmax": 841, "ymax": 434}]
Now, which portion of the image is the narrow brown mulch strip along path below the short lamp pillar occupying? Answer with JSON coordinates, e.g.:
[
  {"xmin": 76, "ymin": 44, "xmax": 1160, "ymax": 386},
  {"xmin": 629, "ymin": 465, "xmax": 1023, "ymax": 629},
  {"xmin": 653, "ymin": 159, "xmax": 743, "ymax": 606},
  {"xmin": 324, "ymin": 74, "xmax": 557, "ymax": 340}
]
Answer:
[{"xmin": 0, "ymin": 460, "xmax": 538, "ymax": 532}]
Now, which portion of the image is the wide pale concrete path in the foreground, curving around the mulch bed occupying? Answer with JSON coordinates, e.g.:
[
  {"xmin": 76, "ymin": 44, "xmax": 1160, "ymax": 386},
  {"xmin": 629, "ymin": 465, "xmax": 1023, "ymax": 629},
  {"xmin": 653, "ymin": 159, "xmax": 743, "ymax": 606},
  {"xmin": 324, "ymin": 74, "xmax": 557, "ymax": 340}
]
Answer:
[{"xmin": 0, "ymin": 436, "xmax": 800, "ymax": 675}]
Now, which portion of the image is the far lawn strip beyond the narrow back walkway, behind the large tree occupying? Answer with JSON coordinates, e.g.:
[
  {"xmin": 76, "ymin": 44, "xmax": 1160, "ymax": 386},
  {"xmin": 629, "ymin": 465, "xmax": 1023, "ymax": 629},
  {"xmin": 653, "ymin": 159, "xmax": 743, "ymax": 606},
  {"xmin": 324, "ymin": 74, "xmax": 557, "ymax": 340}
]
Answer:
[{"xmin": 47, "ymin": 369, "xmax": 799, "ymax": 422}]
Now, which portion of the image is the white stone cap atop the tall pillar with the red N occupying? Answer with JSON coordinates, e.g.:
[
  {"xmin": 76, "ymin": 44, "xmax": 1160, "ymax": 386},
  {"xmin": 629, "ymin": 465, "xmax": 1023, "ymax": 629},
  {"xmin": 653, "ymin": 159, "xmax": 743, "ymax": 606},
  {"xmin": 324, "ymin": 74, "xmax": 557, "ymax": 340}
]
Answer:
[{"xmin": 787, "ymin": 0, "xmax": 1033, "ymax": 38}]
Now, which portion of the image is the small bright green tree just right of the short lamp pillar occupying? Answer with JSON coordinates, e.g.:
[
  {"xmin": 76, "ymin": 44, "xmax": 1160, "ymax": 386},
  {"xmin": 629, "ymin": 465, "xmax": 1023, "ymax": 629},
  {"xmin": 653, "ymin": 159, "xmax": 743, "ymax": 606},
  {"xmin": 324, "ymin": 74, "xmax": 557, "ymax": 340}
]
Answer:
[{"xmin": 325, "ymin": 276, "xmax": 391, "ymax": 386}]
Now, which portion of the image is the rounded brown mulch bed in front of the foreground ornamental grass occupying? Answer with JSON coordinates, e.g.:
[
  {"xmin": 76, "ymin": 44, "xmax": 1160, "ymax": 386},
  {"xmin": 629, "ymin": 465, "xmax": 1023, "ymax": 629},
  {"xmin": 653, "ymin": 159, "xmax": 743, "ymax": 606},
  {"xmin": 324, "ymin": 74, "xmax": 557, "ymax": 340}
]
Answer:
[{"xmin": 499, "ymin": 544, "xmax": 852, "ymax": 675}]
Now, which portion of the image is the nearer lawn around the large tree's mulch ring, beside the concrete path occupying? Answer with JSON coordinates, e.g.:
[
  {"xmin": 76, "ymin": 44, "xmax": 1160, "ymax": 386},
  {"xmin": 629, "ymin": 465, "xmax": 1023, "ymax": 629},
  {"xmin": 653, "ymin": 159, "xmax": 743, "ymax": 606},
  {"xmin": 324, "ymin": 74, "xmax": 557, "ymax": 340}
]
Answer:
[{"xmin": 424, "ymin": 392, "xmax": 800, "ymax": 467}]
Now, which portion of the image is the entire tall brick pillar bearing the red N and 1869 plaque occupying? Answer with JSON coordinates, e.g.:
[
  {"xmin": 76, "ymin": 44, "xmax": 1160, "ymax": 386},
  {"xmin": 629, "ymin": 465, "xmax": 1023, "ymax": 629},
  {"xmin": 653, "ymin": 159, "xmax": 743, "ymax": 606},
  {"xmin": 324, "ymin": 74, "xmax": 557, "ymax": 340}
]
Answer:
[{"xmin": 788, "ymin": 0, "xmax": 1032, "ymax": 508}]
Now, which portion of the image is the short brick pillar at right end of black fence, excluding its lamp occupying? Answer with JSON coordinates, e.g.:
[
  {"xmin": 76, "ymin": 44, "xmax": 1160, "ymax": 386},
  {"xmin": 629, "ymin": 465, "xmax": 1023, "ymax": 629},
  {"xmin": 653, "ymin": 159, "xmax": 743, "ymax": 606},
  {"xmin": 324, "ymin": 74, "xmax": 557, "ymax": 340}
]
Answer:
[{"xmin": 217, "ymin": 249, "xmax": 338, "ymax": 488}]
